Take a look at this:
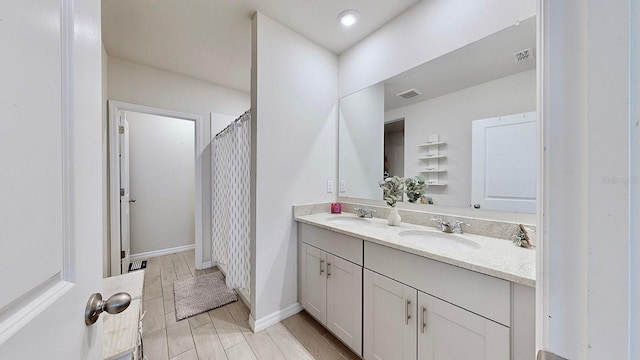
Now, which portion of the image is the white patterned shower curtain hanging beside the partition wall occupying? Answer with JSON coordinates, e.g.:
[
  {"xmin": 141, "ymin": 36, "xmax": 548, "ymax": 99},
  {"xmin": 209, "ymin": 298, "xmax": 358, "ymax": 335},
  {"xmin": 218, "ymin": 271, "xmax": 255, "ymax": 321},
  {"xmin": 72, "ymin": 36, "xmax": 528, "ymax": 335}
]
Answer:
[{"xmin": 211, "ymin": 111, "xmax": 251, "ymax": 289}]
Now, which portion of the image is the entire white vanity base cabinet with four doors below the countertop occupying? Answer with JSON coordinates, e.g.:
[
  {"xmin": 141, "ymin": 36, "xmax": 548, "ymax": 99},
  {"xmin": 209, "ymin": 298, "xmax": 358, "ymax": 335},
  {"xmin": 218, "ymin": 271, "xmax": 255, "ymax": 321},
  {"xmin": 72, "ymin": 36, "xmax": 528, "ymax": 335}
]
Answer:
[{"xmin": 298, "ymin": 222, "xmax": 535, "ymax": 360}]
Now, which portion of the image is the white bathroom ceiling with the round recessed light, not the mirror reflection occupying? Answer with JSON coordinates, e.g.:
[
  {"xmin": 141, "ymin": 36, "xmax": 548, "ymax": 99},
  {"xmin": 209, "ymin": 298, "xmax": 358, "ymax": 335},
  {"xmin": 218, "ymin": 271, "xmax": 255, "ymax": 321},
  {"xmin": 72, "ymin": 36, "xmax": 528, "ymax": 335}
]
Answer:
[{"xmin": 102, "ymin": 0, "xmax": 419, "ymax": 92}]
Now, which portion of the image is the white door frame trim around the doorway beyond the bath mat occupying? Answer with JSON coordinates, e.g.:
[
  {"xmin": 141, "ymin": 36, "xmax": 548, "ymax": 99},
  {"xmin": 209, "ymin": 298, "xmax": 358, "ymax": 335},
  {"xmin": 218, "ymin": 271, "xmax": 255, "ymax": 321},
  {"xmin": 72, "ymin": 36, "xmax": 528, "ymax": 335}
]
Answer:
[{"xmin": 108, "ymin": 100, "xmax": 203, "ymax": 276}]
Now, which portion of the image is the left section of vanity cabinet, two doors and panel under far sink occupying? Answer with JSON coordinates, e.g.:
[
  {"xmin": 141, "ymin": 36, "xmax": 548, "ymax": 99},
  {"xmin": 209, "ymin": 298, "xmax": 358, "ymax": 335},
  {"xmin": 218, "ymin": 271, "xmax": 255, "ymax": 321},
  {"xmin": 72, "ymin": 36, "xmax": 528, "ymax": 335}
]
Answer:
[{"xmin": 300, "ymin": 226, "xmax": 363, "ymax": 355}]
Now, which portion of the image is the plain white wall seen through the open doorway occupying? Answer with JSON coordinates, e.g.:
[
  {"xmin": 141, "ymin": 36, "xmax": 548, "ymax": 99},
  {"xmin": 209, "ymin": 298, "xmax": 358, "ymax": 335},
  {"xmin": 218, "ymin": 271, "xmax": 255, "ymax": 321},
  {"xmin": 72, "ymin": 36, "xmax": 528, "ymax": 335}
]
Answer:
[{"xmin": 126, "ymin": 111, "xmax": 195, "ymax": 255}]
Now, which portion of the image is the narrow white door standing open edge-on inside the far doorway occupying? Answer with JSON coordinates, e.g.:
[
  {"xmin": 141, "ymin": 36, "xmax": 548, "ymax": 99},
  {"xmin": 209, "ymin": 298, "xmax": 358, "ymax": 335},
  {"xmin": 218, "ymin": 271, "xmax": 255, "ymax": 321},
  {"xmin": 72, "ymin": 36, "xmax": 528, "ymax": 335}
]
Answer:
[{"xmin": 118, "ymin": 111, "xmax": 135, "ymax": 274}]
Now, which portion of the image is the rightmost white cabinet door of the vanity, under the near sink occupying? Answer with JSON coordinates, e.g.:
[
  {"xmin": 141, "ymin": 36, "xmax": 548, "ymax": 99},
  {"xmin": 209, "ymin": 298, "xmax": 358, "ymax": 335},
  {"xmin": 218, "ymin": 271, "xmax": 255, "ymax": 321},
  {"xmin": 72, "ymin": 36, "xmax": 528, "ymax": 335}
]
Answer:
[{"xmin": 418, "ymin": 292, "xmax": 510, "ymax": 360}]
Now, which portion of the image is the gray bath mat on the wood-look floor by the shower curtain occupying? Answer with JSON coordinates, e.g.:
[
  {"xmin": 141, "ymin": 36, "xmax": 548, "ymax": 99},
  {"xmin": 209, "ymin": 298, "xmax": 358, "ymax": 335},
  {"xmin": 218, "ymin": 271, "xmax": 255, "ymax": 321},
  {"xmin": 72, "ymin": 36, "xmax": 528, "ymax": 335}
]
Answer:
[{"xmin": 173, "ymin": 271, "xmax": 238, "ymax": 320}]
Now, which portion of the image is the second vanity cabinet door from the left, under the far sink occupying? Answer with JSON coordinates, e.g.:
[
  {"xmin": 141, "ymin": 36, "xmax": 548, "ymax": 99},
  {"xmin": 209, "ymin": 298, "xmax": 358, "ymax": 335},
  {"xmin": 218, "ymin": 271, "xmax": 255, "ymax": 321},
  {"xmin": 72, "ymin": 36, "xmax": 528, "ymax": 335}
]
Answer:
[{"xmin": 327, "ymin": 254, "xmax": 362, "ymax": 355}]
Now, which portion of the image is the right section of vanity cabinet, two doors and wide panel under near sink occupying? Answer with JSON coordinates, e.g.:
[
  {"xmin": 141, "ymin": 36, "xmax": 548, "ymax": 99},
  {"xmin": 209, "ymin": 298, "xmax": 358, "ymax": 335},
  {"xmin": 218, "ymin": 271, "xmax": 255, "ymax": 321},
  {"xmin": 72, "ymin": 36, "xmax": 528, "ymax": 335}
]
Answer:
[{"xmin": 364, "ymin": 243, "xmax": 510, "ymax": 360}]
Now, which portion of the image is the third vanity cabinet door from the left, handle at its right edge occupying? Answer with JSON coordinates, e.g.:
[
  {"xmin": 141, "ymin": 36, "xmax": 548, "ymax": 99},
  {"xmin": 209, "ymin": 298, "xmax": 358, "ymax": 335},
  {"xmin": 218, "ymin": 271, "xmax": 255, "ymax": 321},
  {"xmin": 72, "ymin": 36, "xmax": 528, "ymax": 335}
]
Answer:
[{"xmin": 364, "ymin": 269, "xmax": 417, "ymax": 360}]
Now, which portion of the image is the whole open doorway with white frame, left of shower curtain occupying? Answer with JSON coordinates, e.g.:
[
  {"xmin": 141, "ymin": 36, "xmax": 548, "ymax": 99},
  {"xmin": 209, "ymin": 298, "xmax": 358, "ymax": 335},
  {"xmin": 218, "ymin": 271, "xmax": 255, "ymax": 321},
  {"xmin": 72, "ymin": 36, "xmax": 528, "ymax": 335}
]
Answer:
[{"xmin": 109, "ymin": 101, "xmax": 202, "ymax": 276}]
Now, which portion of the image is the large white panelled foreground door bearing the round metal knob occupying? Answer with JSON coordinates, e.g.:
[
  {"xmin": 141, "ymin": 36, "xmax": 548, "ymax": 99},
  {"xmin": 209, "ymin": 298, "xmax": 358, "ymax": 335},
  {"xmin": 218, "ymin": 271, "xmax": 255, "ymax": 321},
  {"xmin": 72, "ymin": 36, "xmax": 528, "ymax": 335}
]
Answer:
[{"xmin": 0, "ymin": 0, "xmax": 103, "ymax": 359}]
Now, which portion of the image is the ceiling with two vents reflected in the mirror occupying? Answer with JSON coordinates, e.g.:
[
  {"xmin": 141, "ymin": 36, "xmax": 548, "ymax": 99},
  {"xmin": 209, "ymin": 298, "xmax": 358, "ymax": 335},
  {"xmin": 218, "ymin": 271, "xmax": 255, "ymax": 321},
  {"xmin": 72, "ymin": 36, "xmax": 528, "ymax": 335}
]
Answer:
[{"xmin": 384, "ymin": 17, "xmax": 536, "ymax": 111}]
